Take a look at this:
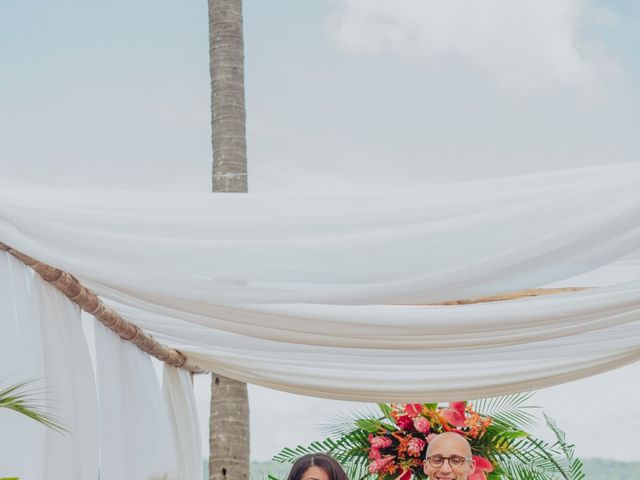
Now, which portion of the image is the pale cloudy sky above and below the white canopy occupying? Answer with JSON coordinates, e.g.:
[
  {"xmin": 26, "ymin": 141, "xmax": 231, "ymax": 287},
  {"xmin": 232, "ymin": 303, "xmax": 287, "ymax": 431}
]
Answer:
[{"xmin": 0, "ymin": 0, "xmax": 640, "ymax": 461}]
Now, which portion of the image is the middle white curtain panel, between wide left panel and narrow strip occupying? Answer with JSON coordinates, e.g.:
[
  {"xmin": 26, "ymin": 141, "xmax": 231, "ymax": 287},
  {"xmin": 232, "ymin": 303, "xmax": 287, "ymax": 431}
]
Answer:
[{"xmin": 95, "ymin": 324, "xmax": 180, "ymax": 480}]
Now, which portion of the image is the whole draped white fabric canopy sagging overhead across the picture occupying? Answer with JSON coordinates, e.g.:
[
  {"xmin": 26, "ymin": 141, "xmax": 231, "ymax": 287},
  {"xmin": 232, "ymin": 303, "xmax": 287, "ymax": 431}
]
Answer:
[{"xmin": 0, "ymin": 165, "xmax": 640, "ymax": 401}]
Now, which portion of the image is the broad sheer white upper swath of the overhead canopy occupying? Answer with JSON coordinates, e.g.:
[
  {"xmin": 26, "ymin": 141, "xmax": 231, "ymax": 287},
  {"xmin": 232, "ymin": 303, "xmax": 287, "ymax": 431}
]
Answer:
[{"xmin": 0, "ymin": 165, "xmax": 640, "ymax": 306}]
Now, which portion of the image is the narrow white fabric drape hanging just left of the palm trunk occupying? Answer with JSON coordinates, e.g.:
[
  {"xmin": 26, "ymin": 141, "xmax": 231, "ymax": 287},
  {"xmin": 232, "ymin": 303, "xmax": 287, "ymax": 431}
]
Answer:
[{"xmin": 162, "ymin": 363, "xmax": 202, "ymax": 480}]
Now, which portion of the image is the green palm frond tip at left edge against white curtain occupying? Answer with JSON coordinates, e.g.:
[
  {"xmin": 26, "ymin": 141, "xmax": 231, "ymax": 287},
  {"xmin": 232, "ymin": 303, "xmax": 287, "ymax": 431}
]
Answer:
[{"xmin": 0, "ymin": 380, "xmax": 69, "ymax": 433}]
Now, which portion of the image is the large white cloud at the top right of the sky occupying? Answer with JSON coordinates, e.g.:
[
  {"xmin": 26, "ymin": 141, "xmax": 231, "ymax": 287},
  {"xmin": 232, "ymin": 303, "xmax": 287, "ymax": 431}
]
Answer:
[{"xmin": 330, "ymin": 0, "xmax": 617, "ymax": 95}]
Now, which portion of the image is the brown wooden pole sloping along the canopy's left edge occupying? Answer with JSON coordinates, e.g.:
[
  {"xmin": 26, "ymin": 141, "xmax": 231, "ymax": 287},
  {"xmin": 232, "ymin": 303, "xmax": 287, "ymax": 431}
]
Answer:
[{"xmin": 0, "ymin": 242, "xmax": 206, "ymax": 373}]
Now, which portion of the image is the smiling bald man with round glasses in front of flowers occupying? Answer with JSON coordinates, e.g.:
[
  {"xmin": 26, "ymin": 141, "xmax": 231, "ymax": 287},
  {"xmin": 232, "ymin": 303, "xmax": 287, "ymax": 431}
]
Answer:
[{"xmin": 424, "ymin": 432, "xmax": 474, "ymax": 480}]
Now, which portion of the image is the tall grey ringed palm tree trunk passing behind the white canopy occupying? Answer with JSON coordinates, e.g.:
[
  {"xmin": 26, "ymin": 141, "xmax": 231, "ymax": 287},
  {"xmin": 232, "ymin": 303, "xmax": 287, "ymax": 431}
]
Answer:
[{"xmin": 208, "ymin": 0, "xmax": 250, "ymax": 480}]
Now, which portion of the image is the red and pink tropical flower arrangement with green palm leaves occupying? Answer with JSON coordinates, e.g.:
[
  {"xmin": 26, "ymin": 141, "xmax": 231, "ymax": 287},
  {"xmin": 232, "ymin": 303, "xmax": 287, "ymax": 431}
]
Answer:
[{"xmin": 274, "ymin": 394, "xmax": 584, "ymax": 480}]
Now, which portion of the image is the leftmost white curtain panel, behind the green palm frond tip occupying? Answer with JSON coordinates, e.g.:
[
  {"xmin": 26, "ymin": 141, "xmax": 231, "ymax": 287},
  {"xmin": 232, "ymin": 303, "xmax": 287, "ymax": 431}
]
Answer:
[{"xmin": 0, "ymin": 253, "xmax": 98, "ymax": 480}]
